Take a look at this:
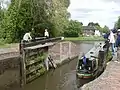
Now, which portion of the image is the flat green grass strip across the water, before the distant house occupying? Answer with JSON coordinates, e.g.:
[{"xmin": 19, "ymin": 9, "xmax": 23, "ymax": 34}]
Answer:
[{"xmin": 65, "ymin": 36, "xmax": 104, "ymax": 41}]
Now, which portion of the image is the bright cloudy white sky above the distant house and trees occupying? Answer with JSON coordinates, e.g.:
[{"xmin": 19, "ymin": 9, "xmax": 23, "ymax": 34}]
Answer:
[{"xmin": 68, "ymin": 0, "xmax": 120, "ymax": 29}]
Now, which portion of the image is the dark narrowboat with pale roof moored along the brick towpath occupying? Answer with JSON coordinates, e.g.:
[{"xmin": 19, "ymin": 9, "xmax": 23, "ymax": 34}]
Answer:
[{"xmin": 76, "ymin": 42, "xmax": 112, "ymax": 79}]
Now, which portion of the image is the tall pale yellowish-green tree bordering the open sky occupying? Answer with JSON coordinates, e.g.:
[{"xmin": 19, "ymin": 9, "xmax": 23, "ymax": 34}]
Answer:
[{"xmin": 48, "ymin": 0, "xmax": 70, "ymax": 35}]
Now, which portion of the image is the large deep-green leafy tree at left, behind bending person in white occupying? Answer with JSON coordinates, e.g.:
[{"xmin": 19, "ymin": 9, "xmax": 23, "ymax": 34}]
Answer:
[{"xmin": 1, "ymin": 0, "xmax": 35, "ymax": 42}]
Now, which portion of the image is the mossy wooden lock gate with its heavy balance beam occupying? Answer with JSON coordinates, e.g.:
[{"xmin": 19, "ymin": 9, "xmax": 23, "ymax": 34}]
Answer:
[{"xmin": 19, "ymin": 37, "xmax": 61, "ymax": 86}]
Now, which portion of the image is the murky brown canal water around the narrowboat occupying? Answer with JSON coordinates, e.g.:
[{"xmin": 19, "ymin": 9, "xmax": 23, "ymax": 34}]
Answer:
[{"xmin": 22, "ymin": 42, "xmax": 94, "ymax": 90}]
